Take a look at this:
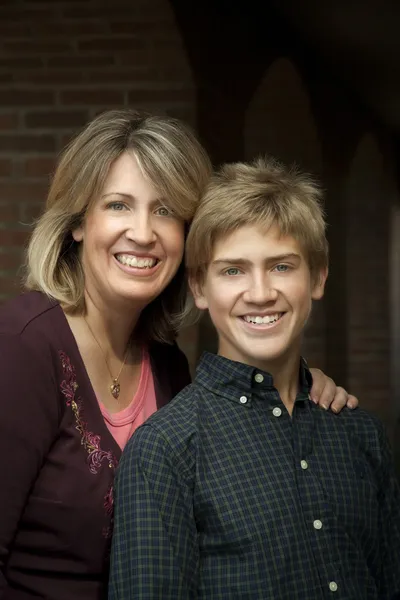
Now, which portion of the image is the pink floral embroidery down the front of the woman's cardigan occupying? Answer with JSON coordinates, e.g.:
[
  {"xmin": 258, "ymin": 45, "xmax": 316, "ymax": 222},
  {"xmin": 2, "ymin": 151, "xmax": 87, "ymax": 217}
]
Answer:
[{"xmin": 59, "ymin": 351, "xmax": 118, "ymax": 538}]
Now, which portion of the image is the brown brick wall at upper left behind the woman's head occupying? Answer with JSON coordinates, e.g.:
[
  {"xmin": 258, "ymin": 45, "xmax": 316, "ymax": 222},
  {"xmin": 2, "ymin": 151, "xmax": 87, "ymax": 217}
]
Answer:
[{"xmin": 0, "ymin": 0, "xmax": 195, "ymax": 301}]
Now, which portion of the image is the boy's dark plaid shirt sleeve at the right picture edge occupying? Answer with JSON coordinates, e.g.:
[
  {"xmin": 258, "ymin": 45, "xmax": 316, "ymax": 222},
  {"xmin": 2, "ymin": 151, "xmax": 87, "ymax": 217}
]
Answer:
[{"xmin": 379, "ymin": 423, "xmax": 400, "ymax": 600}]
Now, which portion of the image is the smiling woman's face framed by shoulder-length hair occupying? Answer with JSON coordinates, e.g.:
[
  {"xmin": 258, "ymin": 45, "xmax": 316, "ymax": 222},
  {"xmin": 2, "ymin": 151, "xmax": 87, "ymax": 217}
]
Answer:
[{"xmin": 73, "ymin": 152, "xmax": 184, "ymax": 310}]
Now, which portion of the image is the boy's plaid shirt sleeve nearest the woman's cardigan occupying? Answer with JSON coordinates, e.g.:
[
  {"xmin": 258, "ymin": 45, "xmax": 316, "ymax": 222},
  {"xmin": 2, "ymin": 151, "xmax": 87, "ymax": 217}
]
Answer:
[{"xmin": 109, "ymin": 425, "xmax": 199, "ymax": 600}]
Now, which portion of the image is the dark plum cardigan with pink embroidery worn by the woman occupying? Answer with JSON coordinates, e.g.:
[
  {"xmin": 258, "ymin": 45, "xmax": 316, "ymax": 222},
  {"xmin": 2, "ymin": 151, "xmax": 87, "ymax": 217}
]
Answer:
[{"xmin": 0, "ymin": 292, "xmax": 190, "ymax": 600}]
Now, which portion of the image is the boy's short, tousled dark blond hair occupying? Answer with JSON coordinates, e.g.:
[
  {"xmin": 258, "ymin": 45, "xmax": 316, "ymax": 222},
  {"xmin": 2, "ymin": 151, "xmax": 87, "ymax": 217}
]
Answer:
[{"xmin": 186, "ymin": 158, "xmax": 328, "ymax": 282}]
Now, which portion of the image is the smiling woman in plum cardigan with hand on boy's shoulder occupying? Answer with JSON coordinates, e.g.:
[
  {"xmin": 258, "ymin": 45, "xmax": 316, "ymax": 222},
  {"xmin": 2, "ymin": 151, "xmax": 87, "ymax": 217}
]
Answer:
[{"xmin": 0, "ymin": 110, "xmax": 354, "ymax": 600}]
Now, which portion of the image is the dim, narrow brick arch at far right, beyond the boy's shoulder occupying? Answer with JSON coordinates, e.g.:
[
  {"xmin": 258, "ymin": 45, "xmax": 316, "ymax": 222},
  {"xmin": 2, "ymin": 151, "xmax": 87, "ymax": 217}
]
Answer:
[{"xmin": 346, "ymin": 134, "xmax": 393, "ymax": 423}]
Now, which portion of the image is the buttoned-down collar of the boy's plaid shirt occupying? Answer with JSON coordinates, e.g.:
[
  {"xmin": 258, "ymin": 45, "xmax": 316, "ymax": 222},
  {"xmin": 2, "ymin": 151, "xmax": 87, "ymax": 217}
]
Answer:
[{"xmin": 195, "ymin": 352, "xmax": 312, "ymax": 406}]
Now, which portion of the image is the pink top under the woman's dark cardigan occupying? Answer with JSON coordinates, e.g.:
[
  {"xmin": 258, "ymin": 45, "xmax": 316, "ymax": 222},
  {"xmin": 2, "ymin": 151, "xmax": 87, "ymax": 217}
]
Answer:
[{"xmin": 98, "ymin": 350, "xmax": 157, "ymax": 450}]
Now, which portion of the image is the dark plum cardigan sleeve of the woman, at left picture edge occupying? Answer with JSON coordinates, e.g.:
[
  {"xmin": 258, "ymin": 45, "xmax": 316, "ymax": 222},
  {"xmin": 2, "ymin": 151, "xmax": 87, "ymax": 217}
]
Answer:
[{"xmin": 0, "ymin": 334, "xmax": 59, "ymax": 600}]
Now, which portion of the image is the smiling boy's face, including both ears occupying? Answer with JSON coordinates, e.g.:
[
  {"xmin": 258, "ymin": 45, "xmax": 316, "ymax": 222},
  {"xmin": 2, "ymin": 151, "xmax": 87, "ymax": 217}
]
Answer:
[{"xmin": 192, "ymin": 225, "xmax": 327, "ymax": 371}]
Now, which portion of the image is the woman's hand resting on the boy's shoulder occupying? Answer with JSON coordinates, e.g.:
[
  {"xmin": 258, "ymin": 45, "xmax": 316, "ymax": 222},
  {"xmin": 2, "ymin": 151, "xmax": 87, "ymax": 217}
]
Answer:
[{"xmin": 310, "ymin": 369, "xmax": 358, "ymax": 413}]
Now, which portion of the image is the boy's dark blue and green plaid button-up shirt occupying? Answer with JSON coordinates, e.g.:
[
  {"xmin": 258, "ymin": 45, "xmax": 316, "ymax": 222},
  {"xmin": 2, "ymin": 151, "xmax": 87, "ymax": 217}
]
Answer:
[{"xmin": 109, "ymin": 354, "xmax": 400, "ymax": 600}]
